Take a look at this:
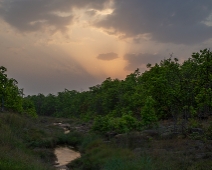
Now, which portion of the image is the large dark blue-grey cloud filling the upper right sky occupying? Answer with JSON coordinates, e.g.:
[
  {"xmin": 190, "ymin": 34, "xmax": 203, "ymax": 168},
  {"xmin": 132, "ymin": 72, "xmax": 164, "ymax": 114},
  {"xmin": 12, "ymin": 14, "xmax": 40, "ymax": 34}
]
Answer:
[{"xmin": 96, "ymin": 0, "xmax": 212, "ymax": 44}]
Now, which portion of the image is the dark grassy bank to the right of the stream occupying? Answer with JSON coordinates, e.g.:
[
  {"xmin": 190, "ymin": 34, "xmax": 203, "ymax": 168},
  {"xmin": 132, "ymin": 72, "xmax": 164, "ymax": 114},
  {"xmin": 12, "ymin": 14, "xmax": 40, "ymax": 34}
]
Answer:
[{"xmin": 66, "ymin": 120, "xmax": 212, "ymax": 170}]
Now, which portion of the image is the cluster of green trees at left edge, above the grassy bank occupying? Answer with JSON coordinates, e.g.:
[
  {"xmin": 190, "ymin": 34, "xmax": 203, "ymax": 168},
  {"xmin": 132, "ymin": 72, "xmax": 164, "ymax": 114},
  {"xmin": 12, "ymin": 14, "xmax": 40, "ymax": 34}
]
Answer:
[{"xmin": 0, "ymin": 66, "xmax": 37, "ymax": 116}]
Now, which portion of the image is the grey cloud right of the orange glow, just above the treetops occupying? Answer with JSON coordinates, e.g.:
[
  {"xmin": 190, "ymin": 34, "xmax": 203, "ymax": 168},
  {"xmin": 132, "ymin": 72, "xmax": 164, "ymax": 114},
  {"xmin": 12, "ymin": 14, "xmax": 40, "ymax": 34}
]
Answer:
[{"xmin": 124, "ymin": 53, "xmax": 165, "ymax": 71}]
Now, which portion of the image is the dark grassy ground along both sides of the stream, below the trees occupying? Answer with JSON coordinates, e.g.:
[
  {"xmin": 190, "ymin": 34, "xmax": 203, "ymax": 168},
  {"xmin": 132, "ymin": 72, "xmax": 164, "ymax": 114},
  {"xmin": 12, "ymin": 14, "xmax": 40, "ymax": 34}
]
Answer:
[{"xmin": 0, "ymin": 113, "xmax": 212, "ymax": 170}]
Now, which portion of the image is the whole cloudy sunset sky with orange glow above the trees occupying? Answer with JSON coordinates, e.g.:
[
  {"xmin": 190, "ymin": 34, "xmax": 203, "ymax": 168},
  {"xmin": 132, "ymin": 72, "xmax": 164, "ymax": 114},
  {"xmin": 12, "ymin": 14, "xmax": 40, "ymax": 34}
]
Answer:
[{"xmin": 0, "ymin": 0, "xmax": 212, "ymax": 95}]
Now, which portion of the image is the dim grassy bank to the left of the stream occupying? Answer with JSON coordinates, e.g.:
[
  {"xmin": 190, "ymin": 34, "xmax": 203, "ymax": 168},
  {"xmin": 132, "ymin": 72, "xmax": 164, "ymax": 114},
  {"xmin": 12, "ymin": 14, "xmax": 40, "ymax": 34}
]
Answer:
[{"xmin": 0, "ymin": 113, "xmax": 76, "ymax": 170}]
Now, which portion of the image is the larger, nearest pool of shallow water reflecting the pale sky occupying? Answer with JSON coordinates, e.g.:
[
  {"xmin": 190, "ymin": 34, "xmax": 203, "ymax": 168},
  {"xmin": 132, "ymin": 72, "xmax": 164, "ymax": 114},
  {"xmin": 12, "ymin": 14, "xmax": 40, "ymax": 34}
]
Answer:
[{"xmin": 54, "ymin": 147, "xmax": 81, "ymax": 167}]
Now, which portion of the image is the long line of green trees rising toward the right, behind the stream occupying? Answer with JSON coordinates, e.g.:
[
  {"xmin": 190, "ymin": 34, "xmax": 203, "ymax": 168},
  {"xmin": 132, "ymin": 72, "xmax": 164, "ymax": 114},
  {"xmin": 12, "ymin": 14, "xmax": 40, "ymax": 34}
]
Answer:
[{"xmin": 27, "ymin": 49, "xmax": 212, "ymax": 130}]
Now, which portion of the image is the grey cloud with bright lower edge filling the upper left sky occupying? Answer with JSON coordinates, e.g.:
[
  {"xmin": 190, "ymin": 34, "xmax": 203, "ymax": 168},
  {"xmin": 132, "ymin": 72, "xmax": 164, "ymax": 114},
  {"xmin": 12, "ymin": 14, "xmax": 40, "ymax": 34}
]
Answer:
[{"xmin": 0, "ymin": 0, "xmax": 108, "ymax": 31}]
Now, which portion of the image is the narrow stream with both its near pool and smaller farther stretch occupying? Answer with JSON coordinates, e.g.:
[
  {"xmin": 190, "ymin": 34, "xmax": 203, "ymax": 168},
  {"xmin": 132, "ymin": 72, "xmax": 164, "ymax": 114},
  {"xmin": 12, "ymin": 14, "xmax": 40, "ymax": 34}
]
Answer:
[{"xmin": 54, "ymin": 123, "xmax": 81, "ymax": 170}]
